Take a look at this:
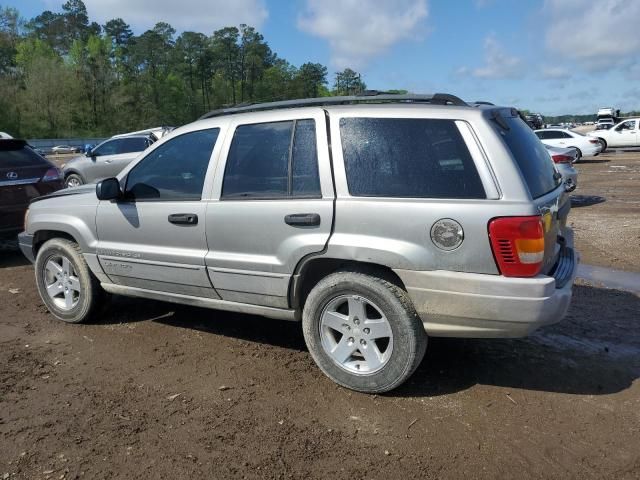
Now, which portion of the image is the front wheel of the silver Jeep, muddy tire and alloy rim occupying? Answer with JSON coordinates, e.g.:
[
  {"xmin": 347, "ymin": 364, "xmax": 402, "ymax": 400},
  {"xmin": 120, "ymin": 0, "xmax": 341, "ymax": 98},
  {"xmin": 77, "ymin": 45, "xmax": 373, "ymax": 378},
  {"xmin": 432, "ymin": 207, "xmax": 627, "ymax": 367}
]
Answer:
[{"xmin": 35, "ymin": 238, "xmax": 104, "ymax": 323}]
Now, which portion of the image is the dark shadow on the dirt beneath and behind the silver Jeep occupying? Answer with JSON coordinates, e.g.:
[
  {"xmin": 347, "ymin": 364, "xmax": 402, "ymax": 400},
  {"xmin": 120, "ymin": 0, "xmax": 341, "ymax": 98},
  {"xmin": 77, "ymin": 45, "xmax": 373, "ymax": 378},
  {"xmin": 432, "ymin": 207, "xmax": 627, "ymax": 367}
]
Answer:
[{"xmin": 90, "ymin": 285, "xmax": 640, "ymax": 397}]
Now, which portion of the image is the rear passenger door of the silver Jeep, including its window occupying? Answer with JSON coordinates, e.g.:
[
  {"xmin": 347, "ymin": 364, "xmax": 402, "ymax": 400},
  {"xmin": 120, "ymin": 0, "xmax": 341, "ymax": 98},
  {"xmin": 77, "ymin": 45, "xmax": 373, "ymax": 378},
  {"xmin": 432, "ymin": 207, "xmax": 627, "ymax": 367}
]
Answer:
[{"xmin": 206, "ymin": 109, "xmax": 334, "ymax": 308}]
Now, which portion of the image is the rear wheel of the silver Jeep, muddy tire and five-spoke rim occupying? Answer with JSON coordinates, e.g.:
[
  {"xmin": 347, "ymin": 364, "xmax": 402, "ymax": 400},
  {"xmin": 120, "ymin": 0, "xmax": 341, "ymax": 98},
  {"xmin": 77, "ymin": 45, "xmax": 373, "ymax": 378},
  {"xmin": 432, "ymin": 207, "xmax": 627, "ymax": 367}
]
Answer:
[{"xmin": 302, "ymin": 271, "xmax": 427, "ymax": 393}]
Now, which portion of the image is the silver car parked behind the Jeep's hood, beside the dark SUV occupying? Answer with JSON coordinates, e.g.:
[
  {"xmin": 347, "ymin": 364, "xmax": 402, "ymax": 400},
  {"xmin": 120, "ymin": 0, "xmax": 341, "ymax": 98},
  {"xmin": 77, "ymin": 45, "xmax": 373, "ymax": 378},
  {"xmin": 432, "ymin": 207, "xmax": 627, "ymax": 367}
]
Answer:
[{"xmin": 62, "ymin": 135, "xmax": 154, "ymax": 187}]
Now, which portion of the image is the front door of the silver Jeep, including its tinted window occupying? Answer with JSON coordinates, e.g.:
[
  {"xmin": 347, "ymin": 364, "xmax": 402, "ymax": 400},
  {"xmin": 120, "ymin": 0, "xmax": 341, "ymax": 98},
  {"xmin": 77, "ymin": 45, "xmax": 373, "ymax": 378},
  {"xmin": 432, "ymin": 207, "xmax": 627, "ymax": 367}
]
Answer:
[{"xmin": 97, "ymin": 128, "xmax": 219, "ymax": 298}]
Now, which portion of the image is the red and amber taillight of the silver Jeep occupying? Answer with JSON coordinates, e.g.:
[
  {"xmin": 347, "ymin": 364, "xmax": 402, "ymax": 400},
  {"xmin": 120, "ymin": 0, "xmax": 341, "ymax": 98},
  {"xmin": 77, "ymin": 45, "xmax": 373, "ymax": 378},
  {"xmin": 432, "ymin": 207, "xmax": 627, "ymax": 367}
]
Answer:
[{"xmin": 489, "ymin": 216, "xmax": 544, "ymax": 277}]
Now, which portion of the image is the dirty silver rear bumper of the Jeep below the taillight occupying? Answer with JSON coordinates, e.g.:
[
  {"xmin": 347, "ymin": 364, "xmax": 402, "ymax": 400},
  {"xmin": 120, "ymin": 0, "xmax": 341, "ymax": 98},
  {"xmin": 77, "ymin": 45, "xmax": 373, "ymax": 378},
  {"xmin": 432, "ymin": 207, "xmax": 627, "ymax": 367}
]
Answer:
[{"xmin": 395, "ymin": 231, "xmax": 578, "ymax": 338}]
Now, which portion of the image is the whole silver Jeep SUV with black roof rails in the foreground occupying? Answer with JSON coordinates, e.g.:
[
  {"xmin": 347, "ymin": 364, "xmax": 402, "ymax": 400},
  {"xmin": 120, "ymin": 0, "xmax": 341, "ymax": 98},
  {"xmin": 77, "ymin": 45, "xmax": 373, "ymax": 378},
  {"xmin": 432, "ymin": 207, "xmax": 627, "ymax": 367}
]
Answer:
[{"xmin": 20, "ymin": 94, "xmax": 576, "ymax": 392}]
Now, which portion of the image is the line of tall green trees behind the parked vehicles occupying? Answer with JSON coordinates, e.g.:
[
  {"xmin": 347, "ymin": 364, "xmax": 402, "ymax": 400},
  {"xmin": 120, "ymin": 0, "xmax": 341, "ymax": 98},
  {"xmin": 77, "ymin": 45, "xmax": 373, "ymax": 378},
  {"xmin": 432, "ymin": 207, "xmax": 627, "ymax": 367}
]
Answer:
[{"xmin": 0, "ymin": 0, "xmax": 366, "ymax": 138}]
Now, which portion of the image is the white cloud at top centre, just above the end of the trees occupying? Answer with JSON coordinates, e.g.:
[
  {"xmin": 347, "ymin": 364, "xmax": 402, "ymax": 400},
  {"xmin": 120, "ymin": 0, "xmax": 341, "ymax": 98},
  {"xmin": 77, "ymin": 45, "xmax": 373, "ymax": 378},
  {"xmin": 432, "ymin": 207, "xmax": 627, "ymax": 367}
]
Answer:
[{"xmin": 298, "ymin": 0, "xmax": 428, "ymax": 69}]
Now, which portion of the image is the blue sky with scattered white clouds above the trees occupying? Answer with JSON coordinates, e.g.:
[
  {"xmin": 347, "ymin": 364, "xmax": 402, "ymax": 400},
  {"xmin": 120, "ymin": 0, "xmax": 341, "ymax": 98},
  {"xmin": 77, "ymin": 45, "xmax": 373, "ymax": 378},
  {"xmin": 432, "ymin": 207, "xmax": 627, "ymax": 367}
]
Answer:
[{"xmin": 5, "ymin": 0, "xmax": 640, "ymax": 115}]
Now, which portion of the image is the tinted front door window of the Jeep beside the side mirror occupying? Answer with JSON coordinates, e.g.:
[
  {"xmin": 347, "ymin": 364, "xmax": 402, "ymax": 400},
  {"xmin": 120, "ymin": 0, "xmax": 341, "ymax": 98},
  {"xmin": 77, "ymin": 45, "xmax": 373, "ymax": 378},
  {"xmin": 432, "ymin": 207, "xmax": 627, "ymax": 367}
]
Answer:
[{"xmin": 125, "ymin": 128, "xmax": 220, "ymax": 200}]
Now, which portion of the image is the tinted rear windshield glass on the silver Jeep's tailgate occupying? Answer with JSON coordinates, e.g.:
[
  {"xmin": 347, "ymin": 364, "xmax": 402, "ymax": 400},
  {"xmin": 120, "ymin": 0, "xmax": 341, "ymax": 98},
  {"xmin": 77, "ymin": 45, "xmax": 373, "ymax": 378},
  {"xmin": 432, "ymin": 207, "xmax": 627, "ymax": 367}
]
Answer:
[{"xmin": 495, "ymin": 116, "xmax": 561, "ymax": 198}]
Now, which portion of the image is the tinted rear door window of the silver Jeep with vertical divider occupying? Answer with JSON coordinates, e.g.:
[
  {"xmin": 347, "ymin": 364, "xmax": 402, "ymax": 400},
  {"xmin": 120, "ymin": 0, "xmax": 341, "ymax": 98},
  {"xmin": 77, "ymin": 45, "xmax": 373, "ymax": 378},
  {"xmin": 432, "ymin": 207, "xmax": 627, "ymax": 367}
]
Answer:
[{"xmin": 222, "ymin": 119, "xmax": 321, "ymax": 199}]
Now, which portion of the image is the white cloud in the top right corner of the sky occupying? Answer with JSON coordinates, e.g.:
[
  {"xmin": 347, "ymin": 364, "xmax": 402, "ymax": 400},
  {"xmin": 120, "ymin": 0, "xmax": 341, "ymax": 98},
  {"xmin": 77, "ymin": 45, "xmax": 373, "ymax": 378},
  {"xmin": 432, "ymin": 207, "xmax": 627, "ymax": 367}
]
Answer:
[{"xmin": 543, "ymin": 0, "xmax": 640, "ymax": 71}]
